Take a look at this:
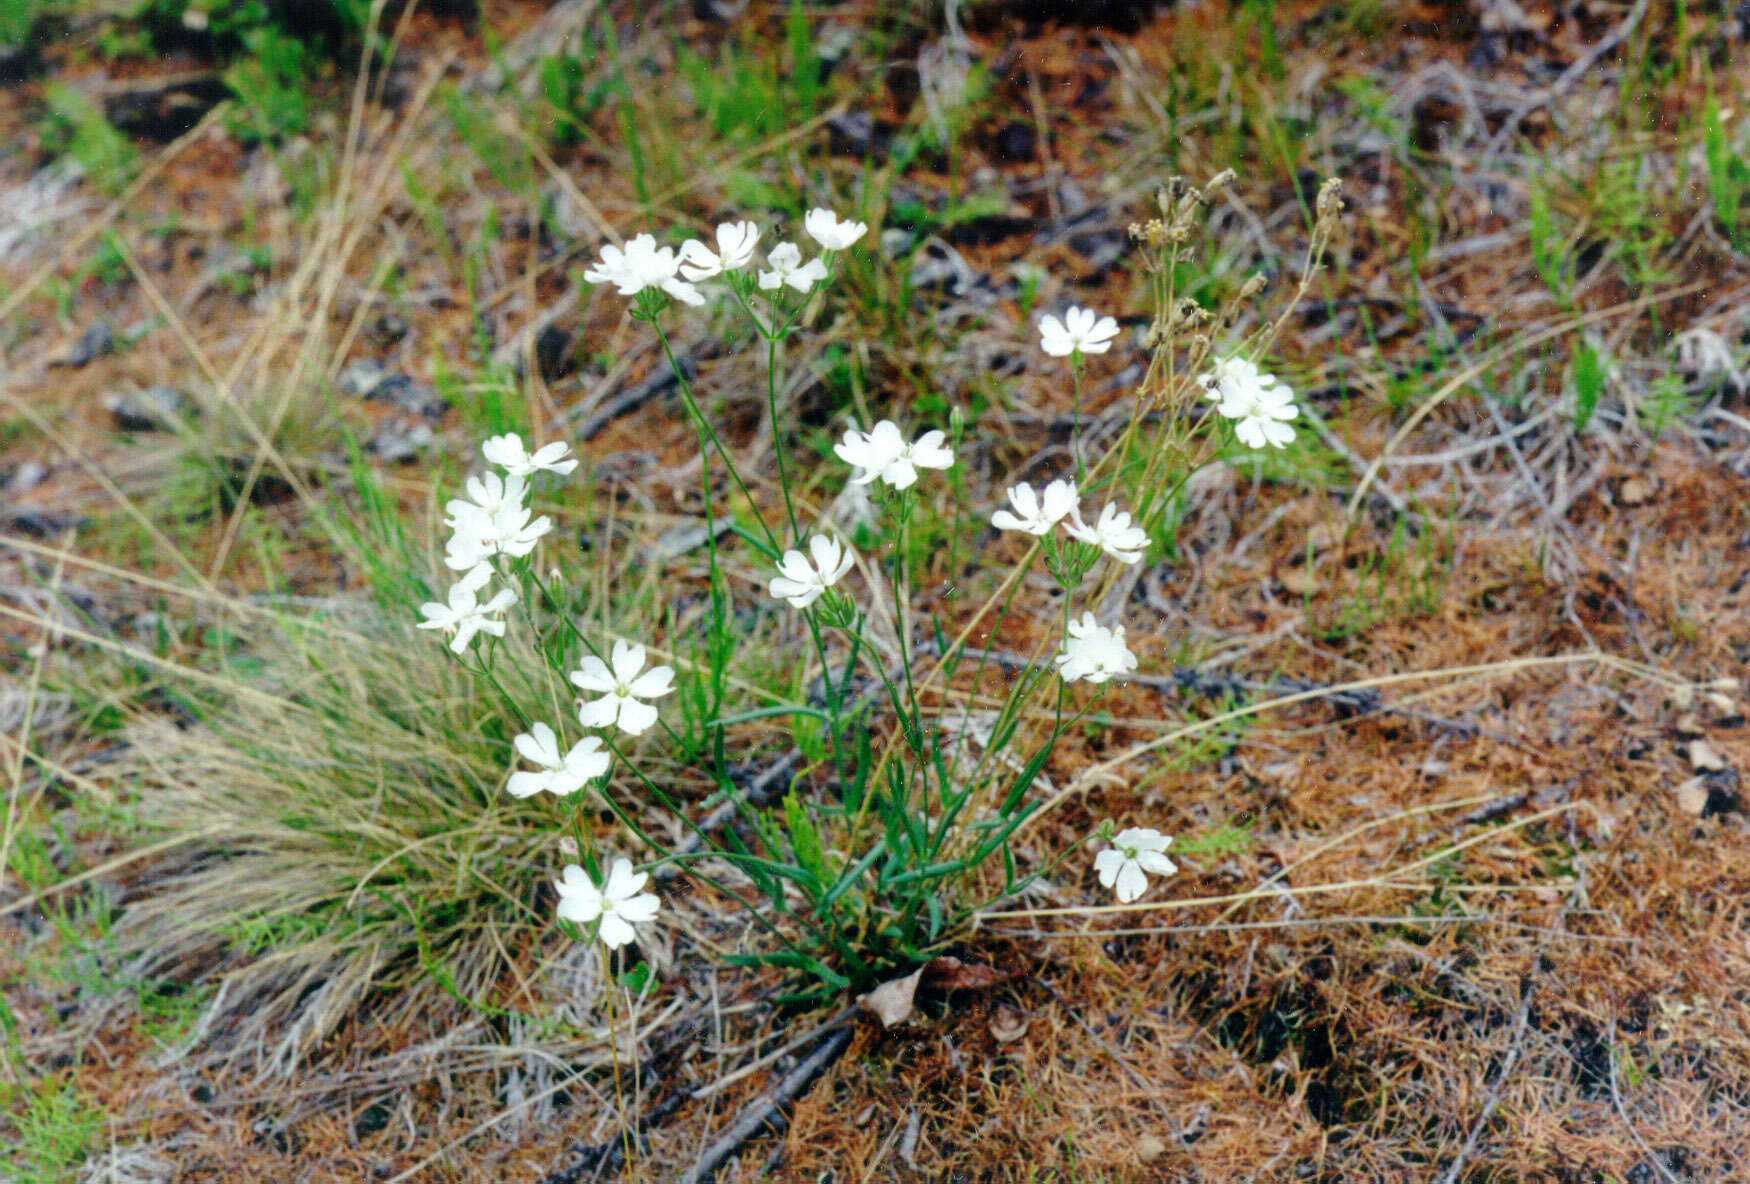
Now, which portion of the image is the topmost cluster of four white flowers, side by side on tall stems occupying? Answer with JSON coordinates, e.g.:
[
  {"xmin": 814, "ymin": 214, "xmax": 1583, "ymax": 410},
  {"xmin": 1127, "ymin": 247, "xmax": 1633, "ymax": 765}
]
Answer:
[{"xmin": 583, "ymin": 208, "xmax": 868, "ymax": 306}]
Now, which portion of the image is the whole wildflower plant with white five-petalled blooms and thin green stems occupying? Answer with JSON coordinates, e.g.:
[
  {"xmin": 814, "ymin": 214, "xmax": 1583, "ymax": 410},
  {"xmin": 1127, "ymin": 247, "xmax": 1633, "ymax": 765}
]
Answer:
[{"xmin": 420, "ymin": 180, "xmax": 1335, "ymax": 999}]
